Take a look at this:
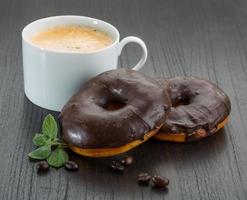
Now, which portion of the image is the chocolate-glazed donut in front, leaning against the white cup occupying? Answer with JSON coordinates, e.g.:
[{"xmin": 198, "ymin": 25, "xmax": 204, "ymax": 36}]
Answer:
[{"xmin": 60, "ymin": 69, "xmax": 171, "ymax": 157}]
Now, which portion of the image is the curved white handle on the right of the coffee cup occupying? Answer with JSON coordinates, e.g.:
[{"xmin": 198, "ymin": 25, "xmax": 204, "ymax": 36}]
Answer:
[{"xmin": 118, "ymin": 36, "xmax": 148, "ymax": 71}]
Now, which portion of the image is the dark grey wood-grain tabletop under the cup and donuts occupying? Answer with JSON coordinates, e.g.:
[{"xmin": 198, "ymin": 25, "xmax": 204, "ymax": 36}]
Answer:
[{"xmin": 0, "ymin": 0, "xmax": 247, "ymax": 200}]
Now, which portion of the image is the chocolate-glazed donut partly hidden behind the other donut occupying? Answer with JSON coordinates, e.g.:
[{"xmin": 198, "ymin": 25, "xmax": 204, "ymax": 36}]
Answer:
[{"xmin": 154, "ymin": 77, "xmax": 231, "ymax": 142}]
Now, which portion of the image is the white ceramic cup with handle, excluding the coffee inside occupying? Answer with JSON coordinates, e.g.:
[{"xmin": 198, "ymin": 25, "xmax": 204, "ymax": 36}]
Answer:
[{"xmin": 22, "ymin": 15, "xmax": 147, "ymax": 111}]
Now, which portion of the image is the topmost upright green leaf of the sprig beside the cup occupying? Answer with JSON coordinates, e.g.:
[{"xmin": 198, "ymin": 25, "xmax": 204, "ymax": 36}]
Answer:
[{"xmin": 42, "ymin": 114, "xmax": 58, "ymax": 139}]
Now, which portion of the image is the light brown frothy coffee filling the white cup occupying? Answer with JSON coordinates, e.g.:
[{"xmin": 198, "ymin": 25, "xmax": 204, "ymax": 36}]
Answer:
[{"xmin": 30, "ymin": 25, "xmax": 113, "ymax": 53}]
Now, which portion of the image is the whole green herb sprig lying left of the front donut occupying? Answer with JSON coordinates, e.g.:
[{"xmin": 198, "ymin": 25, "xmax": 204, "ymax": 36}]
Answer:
[{"xmin": 28, "ymin": 114, "xmax": 69, "ymax": 167}]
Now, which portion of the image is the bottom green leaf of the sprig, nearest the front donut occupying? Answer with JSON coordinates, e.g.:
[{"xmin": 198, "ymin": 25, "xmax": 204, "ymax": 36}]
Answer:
[{"xmin": 47, "ymin": 146, "xmax": 69, "ymax": 167}]
